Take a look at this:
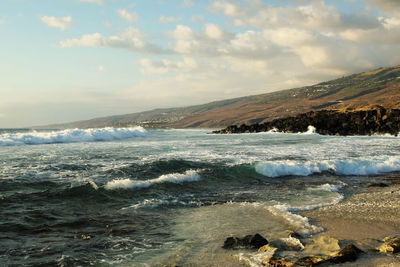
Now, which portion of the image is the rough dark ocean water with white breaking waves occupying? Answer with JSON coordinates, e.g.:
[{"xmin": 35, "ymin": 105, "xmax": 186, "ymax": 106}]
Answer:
[{"xmin": 0, "ymin": 127, "xmax": 400, "ymax": 266}]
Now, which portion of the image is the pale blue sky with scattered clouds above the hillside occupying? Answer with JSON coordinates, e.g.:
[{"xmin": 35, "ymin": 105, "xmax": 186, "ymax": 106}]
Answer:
[{"xmin": 0, "ymin": 0, "xmax": 400, "ymax": 128}]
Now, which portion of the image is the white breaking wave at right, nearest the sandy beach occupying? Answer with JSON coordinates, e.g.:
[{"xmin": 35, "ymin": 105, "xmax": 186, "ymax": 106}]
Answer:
[{"xmin": 255, "ymin": 156, "xmax": 400, "ymax": 178}]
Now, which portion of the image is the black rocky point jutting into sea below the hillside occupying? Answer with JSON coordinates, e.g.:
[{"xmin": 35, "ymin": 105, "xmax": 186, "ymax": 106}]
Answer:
[{"xmin": 212, "ymin": 106, "xmax": 400, "ymax": 136}]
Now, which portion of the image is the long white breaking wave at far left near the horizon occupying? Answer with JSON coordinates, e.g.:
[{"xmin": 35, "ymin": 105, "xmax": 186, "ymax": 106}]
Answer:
[{"xmin": 0, "ymin": 126, "xmax": 149, "ymax": 146}]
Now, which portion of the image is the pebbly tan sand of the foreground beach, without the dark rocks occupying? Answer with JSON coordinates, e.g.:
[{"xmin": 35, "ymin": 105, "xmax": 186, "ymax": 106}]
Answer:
[{"xmin": 301, "ymin": 175, "xmax": 400, "ymax": 266}]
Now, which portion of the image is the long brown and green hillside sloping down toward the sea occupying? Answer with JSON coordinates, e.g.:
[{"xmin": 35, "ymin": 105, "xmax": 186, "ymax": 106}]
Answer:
[{"xmin": 39, "ymin": 66, "xmax": 400, "ymax": 128}]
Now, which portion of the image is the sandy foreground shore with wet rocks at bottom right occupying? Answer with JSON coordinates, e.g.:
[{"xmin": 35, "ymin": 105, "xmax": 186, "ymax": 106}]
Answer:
[{"xmin": 222, "ymin": 182, "xmax": 400, "ymax": 267}]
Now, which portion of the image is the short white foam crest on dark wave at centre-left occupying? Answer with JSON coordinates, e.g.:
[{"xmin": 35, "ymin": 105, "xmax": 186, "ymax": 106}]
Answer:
[{"xmin": 104, "ymin": 170, "xmax": 201, "ymax": 190}]
